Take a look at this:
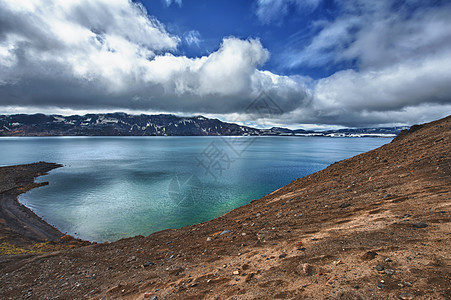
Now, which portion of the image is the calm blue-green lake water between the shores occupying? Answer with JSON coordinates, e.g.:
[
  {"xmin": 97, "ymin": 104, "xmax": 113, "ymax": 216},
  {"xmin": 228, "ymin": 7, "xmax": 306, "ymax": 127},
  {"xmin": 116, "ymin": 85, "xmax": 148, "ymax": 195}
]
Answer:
[{"xmin": 0, "ymin": 137, "xmax": 391, "ymax": 242}]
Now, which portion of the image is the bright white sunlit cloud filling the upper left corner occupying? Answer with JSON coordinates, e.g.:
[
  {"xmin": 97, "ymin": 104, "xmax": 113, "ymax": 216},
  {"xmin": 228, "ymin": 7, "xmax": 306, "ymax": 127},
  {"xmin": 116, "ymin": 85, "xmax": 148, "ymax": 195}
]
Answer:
[{"xmin": 0, "ymin": 0, "xmax": 179, "ymax": 82}]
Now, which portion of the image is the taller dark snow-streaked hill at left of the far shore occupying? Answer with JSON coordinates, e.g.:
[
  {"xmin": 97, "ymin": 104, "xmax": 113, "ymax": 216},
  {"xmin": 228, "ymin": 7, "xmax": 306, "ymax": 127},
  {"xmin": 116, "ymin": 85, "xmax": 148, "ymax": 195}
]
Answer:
[{"xmin": 0, "ymin": 113, "xmax": 259, "ymax": 136}]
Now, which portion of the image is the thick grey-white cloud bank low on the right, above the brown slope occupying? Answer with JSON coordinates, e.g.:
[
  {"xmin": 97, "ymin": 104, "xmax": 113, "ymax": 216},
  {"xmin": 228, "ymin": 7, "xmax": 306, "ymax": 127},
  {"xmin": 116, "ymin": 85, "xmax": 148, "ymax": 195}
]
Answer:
[{"xmin": 293, "ymin": 49, "xmax": 451, "ymax": 126}]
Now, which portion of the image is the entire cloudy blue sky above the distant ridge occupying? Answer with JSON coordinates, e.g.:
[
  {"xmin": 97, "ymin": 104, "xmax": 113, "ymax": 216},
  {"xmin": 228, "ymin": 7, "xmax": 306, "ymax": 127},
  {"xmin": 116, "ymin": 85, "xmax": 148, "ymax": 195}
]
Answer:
[{"xmin": 0, "ymin": 0, "xmax": 451, "ymax": 128}]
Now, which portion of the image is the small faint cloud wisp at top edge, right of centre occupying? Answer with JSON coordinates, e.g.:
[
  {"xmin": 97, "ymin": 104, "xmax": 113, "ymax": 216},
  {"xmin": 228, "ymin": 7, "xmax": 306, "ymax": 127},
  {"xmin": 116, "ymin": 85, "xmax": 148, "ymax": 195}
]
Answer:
[{"xmin": 255, "ymin": 0, "xmax": 321, "ymax": 24}]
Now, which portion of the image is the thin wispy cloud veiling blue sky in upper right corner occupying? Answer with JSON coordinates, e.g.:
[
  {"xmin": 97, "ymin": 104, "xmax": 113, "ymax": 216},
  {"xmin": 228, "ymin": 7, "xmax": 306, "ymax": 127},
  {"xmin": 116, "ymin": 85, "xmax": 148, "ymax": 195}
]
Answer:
[{"xmin": 283, "ymin": 0, "xmax": 451, "ymax": 69}]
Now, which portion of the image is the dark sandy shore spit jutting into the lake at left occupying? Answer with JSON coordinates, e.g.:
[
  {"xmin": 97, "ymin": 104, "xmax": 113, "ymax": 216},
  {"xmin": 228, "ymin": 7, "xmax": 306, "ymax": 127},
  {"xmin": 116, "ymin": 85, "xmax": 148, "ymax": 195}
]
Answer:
[{"xmin": 0, "ymin": 162, "xmax": 67, "ymax": 246}]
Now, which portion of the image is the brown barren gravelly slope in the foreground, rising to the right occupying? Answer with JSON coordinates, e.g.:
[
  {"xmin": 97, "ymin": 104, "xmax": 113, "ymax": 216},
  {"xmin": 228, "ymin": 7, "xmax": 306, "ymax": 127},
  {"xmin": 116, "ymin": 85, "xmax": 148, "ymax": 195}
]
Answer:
[{"xmin": 0, "ymin": 117, "xmax": 451, "ymax": 299}]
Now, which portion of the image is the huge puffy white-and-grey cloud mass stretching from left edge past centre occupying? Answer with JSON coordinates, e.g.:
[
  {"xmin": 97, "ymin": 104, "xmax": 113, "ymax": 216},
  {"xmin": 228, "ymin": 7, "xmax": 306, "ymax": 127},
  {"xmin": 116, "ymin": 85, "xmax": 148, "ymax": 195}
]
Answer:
[{"xmin": 0, "ymin": 0, "xmax": 306, "ymax": 113}]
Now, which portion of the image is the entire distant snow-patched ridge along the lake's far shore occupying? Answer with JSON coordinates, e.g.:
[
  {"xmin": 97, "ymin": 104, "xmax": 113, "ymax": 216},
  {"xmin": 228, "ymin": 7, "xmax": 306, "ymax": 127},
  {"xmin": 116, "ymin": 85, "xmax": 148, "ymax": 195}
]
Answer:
[{"xmin": 0, "ymin": 112, "xmax": 408, "ymax": 137}]
